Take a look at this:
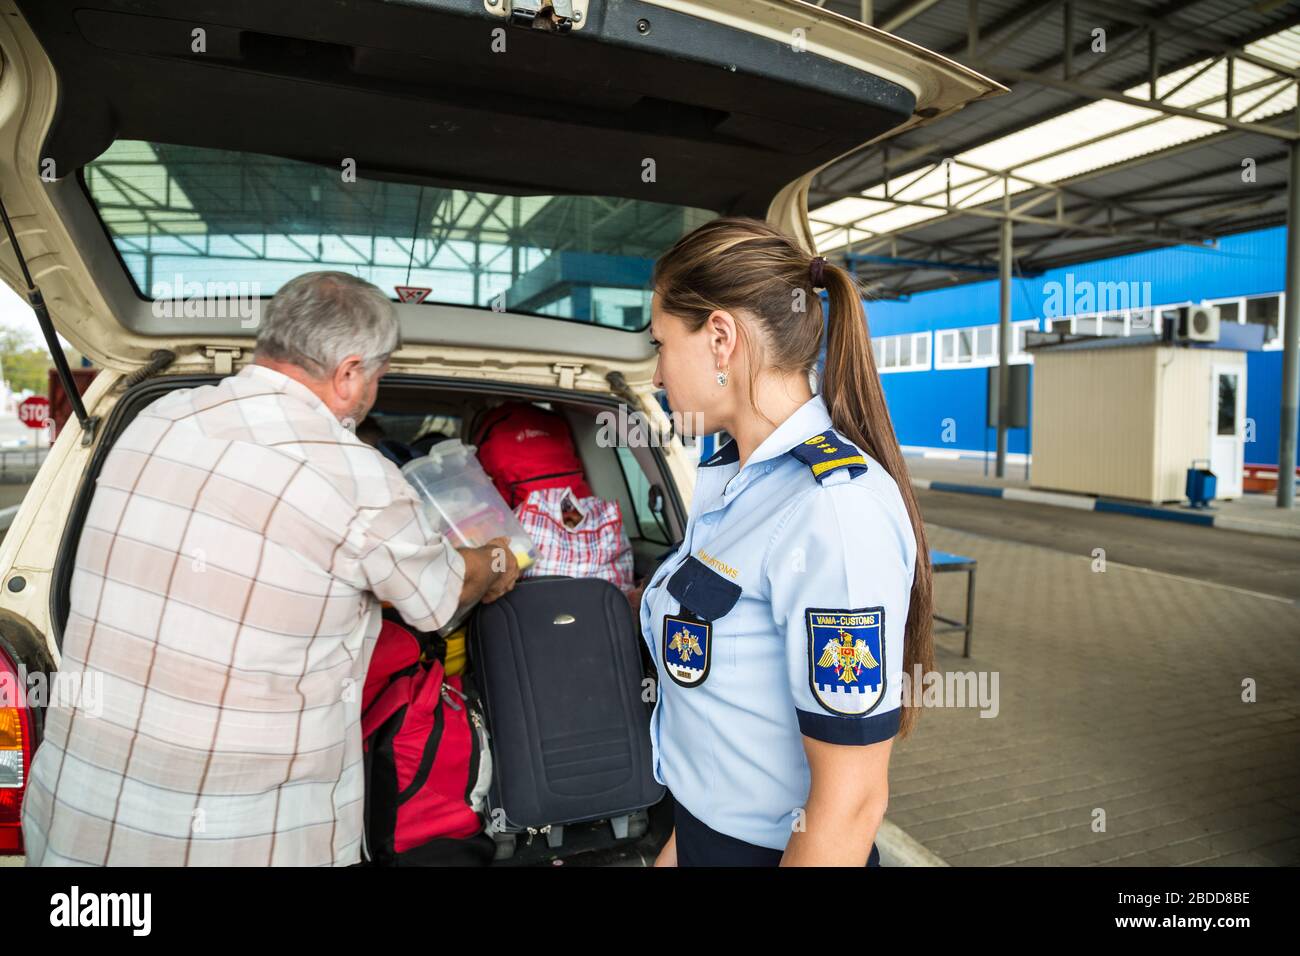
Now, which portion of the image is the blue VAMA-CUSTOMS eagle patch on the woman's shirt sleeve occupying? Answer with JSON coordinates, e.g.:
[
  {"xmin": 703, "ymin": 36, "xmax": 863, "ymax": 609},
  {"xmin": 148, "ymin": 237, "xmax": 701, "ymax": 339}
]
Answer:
[{"xmin": 805, "ymin": 607, "xmax": 885, "ymax": 717}]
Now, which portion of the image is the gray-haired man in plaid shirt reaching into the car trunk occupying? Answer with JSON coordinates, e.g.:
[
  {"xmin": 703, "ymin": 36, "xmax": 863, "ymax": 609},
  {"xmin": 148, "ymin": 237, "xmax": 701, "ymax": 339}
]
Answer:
[{"xmin": 23, "ymin": 272, "xmax": 519, "ymax": 866}]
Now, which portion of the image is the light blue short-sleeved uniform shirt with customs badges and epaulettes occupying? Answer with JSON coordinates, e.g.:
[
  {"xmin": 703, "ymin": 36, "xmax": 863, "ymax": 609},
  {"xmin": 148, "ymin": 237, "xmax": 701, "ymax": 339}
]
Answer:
[{"xmin": 641, "ymin": 395, "xmax": 917, "ymax": 849}]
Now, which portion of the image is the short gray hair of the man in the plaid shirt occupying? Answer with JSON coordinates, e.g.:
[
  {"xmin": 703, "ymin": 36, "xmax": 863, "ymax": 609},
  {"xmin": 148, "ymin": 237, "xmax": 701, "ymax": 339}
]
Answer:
[{"xmin": 257, "ymin": 272, "xmax": 402, "ymax": 378}]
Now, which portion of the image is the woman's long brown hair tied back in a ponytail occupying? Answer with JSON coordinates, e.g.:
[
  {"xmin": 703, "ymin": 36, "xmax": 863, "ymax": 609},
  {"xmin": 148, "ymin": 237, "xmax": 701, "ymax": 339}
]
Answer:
[{"xmin": 654, "ymin": 217, "xmax": 935, "ymax": 737}]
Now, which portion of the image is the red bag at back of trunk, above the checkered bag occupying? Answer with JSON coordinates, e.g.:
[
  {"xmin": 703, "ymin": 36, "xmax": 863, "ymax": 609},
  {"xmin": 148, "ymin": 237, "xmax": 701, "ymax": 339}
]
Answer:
[{"xmin": 472, "ymin": 402, "xmax": 592, "ymax": 509}]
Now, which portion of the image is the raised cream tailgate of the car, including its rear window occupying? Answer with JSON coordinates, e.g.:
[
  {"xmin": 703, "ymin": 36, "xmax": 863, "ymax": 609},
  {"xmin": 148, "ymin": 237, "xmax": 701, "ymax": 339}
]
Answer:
[{"xmin": 0, "ymin": 0, "xmax": 1001, "ymax": 381}]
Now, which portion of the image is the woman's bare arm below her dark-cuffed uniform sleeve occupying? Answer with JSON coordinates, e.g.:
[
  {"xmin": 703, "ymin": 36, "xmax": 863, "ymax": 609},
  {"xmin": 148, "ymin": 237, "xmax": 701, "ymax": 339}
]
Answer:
[{"xmin": 781, "ymin": 736, "xmax": 893, "ymax": 866}]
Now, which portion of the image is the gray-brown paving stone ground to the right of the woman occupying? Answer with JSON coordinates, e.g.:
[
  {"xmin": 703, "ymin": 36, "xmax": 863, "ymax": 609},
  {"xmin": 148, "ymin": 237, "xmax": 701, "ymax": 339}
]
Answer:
[{"xmin": 888, "ymin": 527, "xmax": 1300, "ymax": 866}]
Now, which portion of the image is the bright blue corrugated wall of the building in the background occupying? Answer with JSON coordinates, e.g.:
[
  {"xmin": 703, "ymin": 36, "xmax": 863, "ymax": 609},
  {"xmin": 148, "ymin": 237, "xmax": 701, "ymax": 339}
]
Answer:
[{"xmin": 867, "ymin": 226, "xmax": 1287, "ymax": 464}]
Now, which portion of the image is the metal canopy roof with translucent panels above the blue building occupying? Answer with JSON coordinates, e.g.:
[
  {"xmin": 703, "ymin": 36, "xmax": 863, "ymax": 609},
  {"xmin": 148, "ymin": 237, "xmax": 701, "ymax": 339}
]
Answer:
[{"xmin": 810, "ymin": 0, "xmax": 1300, "ymax": 298}]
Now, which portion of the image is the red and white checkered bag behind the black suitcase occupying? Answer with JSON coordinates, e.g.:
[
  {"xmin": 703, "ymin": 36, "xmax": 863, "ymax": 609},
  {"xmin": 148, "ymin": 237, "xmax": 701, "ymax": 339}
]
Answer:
[{"xmin": 515, "ymin": 488, "xmax": 633, "ymax": 591}]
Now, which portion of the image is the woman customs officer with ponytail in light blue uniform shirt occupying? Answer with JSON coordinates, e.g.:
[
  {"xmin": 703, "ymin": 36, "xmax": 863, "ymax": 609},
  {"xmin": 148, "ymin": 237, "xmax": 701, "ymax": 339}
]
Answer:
[{"xmin": 641, "ymin": 219, "xmax": 933, "ymax": 866}]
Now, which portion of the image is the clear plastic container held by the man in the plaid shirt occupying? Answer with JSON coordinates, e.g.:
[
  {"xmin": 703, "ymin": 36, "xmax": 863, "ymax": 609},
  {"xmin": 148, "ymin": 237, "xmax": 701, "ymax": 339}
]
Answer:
[{"xmin": 402, "ymin": 438, "xmax": 537, "ymax": 570}]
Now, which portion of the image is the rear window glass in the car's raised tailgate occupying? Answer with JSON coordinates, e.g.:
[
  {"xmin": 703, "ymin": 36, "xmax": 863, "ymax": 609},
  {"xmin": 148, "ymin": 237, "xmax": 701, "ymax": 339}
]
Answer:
[{"xmin": 82, "ymin": 140, "xmax": 716, "ymax": 332}]
